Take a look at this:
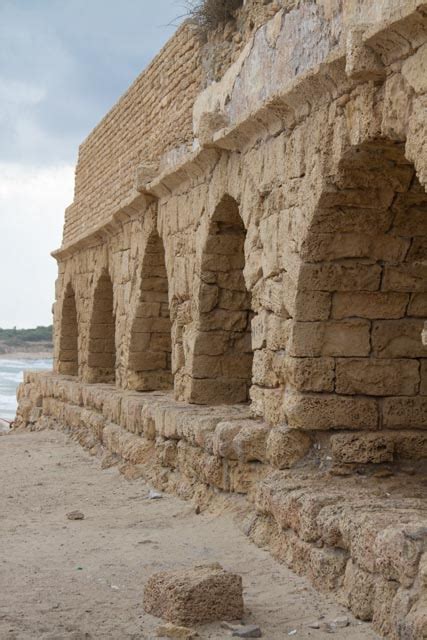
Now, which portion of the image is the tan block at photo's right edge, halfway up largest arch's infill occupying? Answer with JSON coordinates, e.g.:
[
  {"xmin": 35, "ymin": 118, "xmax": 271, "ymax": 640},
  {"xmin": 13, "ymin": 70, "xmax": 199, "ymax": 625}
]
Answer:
[{"xmin": 372, "ymin": 318, "xmax": 427, "ymax": 358}]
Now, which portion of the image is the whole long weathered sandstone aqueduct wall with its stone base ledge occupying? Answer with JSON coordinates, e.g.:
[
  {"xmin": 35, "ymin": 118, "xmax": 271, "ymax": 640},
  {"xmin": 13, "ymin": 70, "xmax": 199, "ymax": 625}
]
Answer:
[{"xmin": 15, "ymin": 0, "xmax": 427, "ymax": 640}]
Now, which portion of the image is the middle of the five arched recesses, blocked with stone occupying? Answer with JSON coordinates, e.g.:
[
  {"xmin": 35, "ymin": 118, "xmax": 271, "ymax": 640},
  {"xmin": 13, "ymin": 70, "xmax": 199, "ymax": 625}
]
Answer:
[{"xmin": 128, "ymin": 230, "xmax": 173, "ymax": 391}]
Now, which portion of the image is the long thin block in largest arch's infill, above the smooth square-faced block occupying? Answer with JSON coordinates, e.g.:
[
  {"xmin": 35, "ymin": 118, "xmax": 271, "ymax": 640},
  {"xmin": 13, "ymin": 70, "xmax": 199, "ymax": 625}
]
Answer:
[{"xmin": 331, "ymin": 291, "xmax": 408, "ymax": 320}]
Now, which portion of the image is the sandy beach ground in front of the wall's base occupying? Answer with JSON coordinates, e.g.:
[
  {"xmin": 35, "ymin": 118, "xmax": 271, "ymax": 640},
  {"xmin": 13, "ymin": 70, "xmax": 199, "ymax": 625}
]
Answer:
[{"xmin": 0, "ymin": 431, "xmax": 378, "ymax": 640}]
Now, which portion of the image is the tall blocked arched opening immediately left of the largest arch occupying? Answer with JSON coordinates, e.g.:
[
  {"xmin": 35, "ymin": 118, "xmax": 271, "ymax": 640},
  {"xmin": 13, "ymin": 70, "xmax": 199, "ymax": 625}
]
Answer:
[{"xmin": 187, "ymin": 195, "xmax": 252, "ymax": 404}]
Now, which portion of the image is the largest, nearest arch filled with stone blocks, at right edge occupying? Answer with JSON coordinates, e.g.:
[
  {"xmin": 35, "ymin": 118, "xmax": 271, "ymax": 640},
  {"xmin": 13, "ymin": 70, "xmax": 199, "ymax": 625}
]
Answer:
[{"xmin": 284, "ymin": 139, "xmax": 427, "ymax": 430}]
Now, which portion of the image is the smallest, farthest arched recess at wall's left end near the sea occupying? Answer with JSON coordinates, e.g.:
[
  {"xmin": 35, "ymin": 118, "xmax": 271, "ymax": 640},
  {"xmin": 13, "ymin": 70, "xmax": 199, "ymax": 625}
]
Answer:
[{"xmin": 58, "ymin": 283, "xmax": 79, "ymax": 376}]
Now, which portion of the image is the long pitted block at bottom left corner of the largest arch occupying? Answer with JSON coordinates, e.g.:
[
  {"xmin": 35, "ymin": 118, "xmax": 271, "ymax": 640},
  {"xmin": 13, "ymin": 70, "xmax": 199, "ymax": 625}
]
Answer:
[{"xmin": 283, "ymin": 393, "xmax": 378, "ymax": 430}]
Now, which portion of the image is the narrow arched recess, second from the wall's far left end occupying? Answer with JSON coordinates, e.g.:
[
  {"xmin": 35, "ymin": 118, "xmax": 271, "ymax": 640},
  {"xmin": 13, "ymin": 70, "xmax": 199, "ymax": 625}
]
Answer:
[{"xmin": 87, "ymin": 271, "xmax": 116, "ymax": 382}]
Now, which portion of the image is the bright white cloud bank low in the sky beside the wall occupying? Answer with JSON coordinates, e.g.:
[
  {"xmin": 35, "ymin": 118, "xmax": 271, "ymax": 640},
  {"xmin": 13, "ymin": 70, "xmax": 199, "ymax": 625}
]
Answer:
[{"xmin": 0, "ymin": 163, "xmax": 74, "ymax": 327}]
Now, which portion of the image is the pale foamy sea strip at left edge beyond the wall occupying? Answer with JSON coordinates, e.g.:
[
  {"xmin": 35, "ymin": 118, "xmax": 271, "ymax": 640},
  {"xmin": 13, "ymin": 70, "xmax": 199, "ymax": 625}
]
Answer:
[{"xmin": 0, "ymin": 354, "xmax": 52, "ymax": 430}]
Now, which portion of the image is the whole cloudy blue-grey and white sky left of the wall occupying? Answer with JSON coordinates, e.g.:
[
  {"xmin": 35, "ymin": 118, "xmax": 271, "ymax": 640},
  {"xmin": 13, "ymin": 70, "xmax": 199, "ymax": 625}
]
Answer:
[{"xmin": 0, "ymin": 0, "xmax": 184, "ymax": 327}]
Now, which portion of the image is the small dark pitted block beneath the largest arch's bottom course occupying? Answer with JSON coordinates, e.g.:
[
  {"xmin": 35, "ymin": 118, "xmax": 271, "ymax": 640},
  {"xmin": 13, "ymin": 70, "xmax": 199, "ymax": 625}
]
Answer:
[{"xmin": 331, "ymin": 433, "xmax": 394, "ymax": 464}]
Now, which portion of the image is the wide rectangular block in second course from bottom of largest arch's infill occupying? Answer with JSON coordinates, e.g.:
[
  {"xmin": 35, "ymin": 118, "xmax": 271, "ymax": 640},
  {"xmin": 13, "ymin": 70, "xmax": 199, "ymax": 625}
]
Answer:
[{"xmin": 335, "ymin": 358, "xmax": 420, "ymax": 396}]
